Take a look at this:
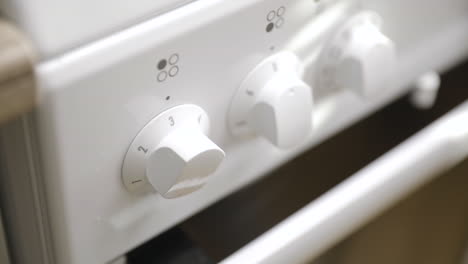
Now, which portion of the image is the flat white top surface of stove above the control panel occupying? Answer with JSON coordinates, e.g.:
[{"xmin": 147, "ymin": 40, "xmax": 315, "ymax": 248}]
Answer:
[{"xmin": 0, "ymin": 0, "xmax": 194, "ymax": 58}]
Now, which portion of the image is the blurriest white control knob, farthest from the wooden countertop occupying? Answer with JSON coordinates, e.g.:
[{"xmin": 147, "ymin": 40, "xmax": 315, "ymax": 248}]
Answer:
[{"xmin": 318, "ymin": 11, "xmax": 396, "ymax": 97}]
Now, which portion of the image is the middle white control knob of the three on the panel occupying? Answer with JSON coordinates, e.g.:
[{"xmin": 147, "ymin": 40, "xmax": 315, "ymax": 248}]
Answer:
[{"xmin": 229, "ymin": 52, "xmax": 313, "ymax": 148}]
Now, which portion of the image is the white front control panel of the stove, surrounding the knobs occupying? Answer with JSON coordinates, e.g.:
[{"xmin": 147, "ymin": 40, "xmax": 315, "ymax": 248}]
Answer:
[{"xmin": 3, "ymin": 0, "xmax": 468, "ymax": 264}]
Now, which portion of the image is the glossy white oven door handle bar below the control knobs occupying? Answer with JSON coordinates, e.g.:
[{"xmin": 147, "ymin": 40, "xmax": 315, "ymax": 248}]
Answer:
[{"xmin": 221, "ymin": 101, "xmax": 468, "ymax": 264}]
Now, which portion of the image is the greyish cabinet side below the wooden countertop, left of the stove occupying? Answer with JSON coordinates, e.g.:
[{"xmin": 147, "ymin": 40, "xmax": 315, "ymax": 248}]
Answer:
[{"xmin": 0, "ymin": 114, "xmax": 55, "ymax": 264}]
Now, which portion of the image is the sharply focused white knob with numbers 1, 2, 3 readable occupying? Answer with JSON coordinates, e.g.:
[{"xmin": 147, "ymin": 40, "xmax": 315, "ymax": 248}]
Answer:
[{"xmin": 122, "ymin": 105, "xmax": 224, "ymax": 198}]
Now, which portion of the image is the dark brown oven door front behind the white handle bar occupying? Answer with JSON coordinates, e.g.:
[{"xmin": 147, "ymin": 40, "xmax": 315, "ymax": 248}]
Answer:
[{"xmin": 128, "ymin": 58, "xmax": 468, "ymax": 264}]
